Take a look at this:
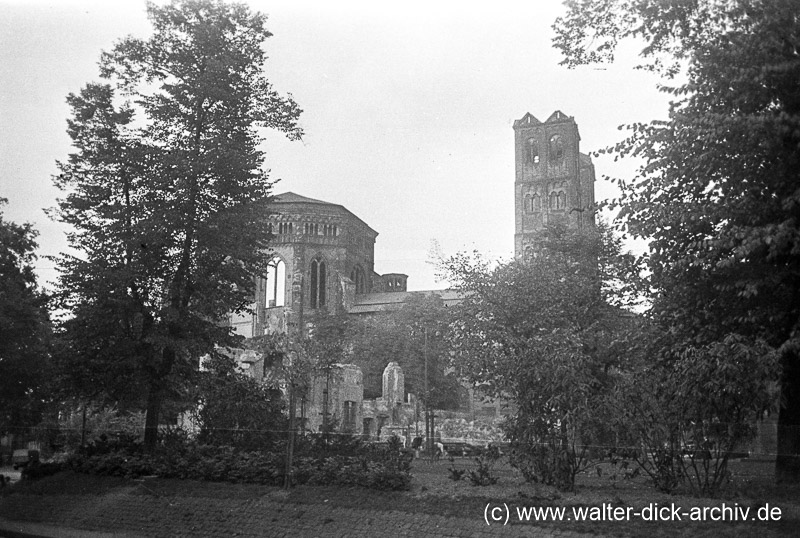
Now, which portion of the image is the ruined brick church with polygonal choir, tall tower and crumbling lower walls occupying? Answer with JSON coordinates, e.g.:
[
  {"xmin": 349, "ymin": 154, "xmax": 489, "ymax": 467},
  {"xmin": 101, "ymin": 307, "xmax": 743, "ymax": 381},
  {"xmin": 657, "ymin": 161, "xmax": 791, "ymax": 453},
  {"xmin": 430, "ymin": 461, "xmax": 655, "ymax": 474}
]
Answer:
[{"xmin": 230, "ymin": 111, "xmax": 595, "ymax": 437}]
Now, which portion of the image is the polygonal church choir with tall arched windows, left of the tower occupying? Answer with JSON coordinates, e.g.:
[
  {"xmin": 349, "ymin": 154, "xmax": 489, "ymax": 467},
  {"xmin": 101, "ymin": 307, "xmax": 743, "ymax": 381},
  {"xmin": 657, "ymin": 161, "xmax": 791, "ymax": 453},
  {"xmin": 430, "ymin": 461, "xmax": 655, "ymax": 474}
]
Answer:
[{"xmin": 230, "ymin": 192, "xmax": 408, "ymax": 338}]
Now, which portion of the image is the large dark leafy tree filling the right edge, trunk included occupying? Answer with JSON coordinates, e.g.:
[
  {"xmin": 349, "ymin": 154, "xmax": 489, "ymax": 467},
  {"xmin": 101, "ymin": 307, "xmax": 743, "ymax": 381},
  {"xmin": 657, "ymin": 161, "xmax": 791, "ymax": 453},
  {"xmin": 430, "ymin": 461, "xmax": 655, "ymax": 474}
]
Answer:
[{"xmin": 555, "ymin": 0, "xmax": 800, "ymax": 482}]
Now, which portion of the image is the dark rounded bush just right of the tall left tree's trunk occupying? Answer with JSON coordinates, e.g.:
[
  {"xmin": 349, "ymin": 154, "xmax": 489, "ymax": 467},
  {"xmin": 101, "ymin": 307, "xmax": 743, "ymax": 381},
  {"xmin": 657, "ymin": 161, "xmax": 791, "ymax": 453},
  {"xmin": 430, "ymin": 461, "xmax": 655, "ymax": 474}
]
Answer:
[{"xmin": 193, "ymin": 355, "xmax": 287, "ymax": 450}]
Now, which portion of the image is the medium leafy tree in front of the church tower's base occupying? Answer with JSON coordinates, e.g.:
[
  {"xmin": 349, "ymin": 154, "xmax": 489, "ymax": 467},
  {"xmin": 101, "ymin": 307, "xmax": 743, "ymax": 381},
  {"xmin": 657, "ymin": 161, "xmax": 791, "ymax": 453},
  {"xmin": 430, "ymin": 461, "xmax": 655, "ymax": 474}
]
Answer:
[{"xmin": 445, "ymin": 226, "xmax": 630, "ymax": 489}]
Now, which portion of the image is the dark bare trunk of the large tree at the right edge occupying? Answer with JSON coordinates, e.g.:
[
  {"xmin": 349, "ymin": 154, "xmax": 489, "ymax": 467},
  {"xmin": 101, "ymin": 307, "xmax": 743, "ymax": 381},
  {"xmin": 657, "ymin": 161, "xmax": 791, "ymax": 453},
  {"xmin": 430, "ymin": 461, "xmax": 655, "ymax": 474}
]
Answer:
[{"xmin": 775, "ymin": 351, "xmax": 800, "ymax": 483}]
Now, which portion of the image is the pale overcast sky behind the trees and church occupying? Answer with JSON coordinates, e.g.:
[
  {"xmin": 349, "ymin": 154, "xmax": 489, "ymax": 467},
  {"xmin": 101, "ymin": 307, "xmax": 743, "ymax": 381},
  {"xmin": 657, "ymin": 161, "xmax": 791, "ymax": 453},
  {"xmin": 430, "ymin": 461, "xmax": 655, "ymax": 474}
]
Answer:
[{"xmin": 0, "ymin": 0, "xmax": 667, "ymax": 290}]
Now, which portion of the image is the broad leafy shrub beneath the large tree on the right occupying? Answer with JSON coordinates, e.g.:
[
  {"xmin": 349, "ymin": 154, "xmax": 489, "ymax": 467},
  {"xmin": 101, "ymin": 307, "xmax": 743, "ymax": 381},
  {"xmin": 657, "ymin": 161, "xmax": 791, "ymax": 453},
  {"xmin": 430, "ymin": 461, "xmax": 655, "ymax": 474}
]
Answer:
[{"xmin": 614, "ymin": 335, "xmax": 778, "ymax": 495}]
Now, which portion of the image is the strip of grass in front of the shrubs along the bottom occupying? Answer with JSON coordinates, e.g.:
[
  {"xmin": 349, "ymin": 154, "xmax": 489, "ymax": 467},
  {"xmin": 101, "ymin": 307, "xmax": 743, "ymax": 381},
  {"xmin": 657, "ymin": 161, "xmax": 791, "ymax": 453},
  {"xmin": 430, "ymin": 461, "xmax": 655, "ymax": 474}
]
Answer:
[{"xmin": 0, "ymin": 459, "xmax": 800, "ymax": 538}]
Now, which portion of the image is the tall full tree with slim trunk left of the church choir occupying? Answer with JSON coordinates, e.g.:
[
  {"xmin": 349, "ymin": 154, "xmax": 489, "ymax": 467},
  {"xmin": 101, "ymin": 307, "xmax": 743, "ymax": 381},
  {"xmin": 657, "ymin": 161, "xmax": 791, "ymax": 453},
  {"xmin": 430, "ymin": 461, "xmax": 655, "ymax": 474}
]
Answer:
[{"xmin": 55, "ymin": 0, "xmax": 301, "ymax": 449}]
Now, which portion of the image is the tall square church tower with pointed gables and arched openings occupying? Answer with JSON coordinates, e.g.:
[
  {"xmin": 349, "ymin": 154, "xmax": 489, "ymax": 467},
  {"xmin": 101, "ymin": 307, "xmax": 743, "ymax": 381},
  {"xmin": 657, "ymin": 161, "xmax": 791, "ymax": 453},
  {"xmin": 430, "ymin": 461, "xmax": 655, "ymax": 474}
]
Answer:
[{"xmin": 514, "ymin": 110, "xmax": 595, "ymax": 257}]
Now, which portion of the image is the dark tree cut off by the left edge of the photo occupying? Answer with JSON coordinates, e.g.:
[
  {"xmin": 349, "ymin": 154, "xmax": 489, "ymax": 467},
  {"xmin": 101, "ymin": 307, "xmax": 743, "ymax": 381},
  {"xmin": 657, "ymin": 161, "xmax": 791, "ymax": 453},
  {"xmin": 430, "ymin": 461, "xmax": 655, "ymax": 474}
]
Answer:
[{"xmin": 0, "ymin": 198, "xmax": 49, "ymax": 433}]
